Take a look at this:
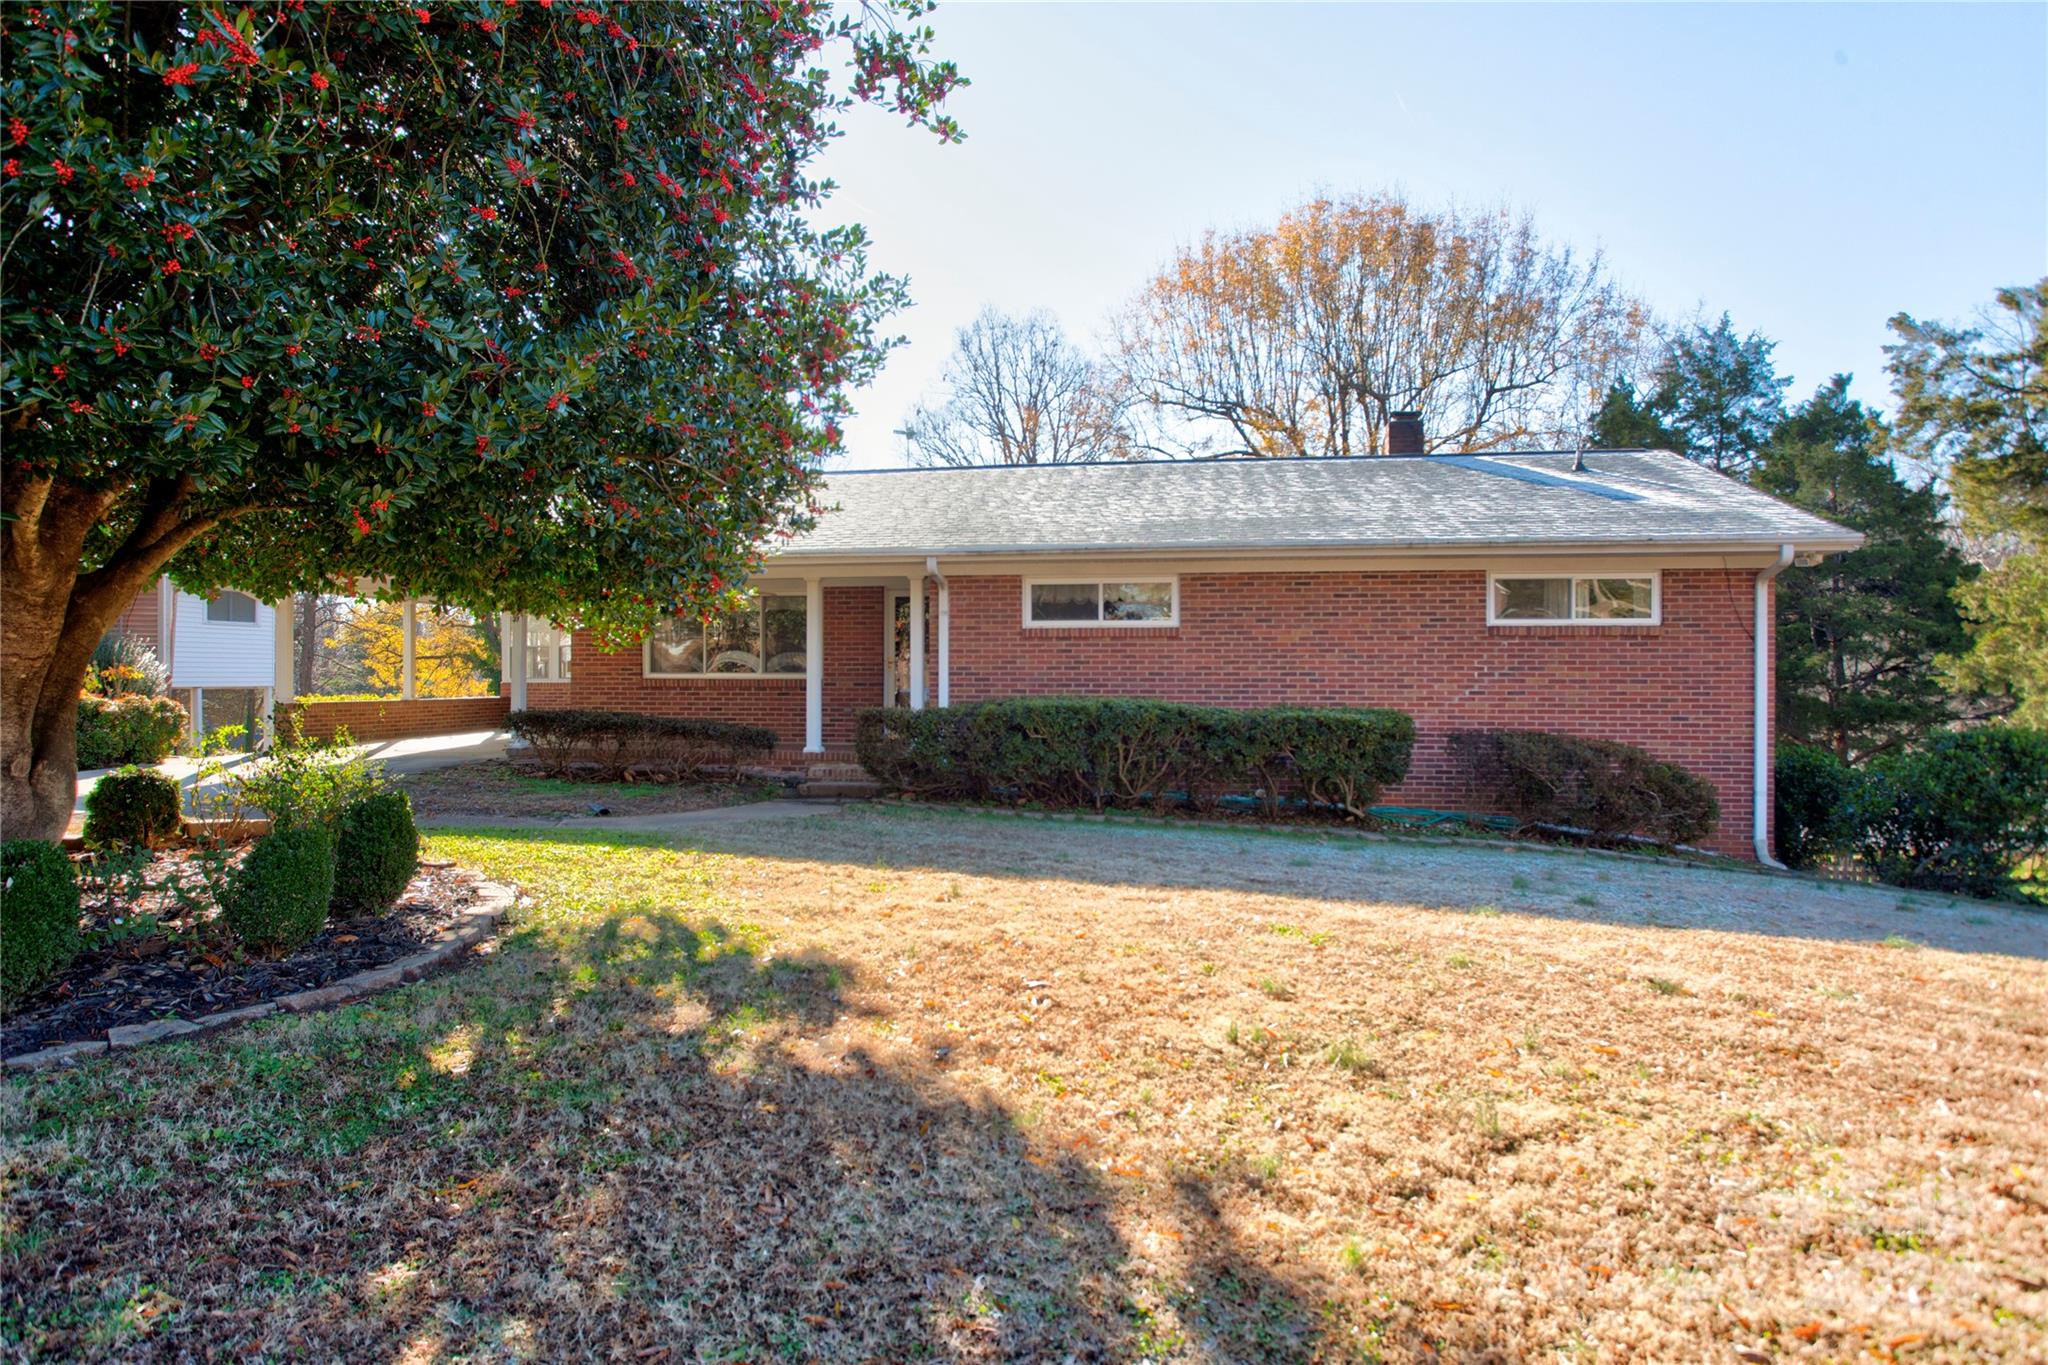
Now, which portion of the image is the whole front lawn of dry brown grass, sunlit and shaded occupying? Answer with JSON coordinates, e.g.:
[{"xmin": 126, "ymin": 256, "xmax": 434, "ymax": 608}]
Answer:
[{"xmin": 0, "ymin": 808, "xmax": 2048, "ymax": 1361}]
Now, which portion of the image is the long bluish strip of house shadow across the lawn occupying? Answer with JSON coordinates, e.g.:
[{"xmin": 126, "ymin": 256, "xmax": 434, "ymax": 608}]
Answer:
[{"xmin": 659, "ymin": 806, "xmax": 2048, "ymax": 958}]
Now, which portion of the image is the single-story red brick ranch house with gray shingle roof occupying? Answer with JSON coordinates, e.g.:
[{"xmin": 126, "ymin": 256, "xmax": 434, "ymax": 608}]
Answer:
[{"xmin": 506, "ymin": 450, "xmax": 1862, "ymax": 857}]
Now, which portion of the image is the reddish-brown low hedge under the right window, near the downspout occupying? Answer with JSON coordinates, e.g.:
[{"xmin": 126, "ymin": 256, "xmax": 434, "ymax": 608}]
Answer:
[{"xmin": 1450, "ymin": 731, "xmax": 1720, "ymax": 845}]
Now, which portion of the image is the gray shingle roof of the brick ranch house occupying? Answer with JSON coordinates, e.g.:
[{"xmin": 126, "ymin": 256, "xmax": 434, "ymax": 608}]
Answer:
[{"xmin": 782, "ymin": 450, "xmax": 1862, "ymax": 559}]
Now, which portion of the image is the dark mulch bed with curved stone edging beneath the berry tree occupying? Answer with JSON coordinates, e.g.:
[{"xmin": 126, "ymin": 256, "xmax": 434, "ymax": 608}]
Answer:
[{"xmin": 0, "ymin": 853, "xmax": 477, "ymax": 1056}]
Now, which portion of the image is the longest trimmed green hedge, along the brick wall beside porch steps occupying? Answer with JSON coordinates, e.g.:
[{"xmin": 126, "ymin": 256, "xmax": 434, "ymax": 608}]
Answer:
[{"xmin": 854, "ymin": 698, "xmax": 1415, "ymax": 817}]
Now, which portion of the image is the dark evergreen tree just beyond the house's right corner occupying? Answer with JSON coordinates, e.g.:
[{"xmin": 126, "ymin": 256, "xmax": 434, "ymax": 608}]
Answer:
[{"xmin": 1753, "ymin": 375, "xmax": 1976, "ymax": 761}]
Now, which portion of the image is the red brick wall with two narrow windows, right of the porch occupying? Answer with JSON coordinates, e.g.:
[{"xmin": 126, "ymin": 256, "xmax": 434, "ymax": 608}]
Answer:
[{"xmin": 937, "ymin": 569, "xmax": 1753, "ymax": 853}]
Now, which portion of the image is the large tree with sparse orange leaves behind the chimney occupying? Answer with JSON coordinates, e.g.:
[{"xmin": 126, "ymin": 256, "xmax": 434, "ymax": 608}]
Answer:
[{"xmin": 1118, "ymin": 194, "xmax": 1649, "ymax": 456}]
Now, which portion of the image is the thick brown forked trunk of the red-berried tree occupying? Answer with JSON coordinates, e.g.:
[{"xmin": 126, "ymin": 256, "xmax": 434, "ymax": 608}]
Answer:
[{"xmin": 0, "ymin": 479, "xmax": 213, "ymax": 839}]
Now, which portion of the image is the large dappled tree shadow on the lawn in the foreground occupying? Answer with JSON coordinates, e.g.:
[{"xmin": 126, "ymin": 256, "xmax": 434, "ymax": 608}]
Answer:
[{"xmin": 0, "ymin": 875, "xmax": 1392, "ymax": 1361}]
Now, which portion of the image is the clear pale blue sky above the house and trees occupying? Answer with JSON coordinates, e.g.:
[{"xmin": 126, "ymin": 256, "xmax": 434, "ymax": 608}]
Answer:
[{"xmin": 806, "ymin": 4, "xmax": 2048, "ymax": 467}]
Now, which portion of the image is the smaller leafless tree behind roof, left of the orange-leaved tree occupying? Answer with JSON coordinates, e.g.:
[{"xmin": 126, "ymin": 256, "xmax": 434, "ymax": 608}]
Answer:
[{"xmin": 899, "ymin": 309, "xmax": 1128, "ymax": 465}]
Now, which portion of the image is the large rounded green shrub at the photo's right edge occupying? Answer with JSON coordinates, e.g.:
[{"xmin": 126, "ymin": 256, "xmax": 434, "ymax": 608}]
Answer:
[{"xmin": 1849, "ymin": 724, "xmax": 2048, "ymax": 896}]
